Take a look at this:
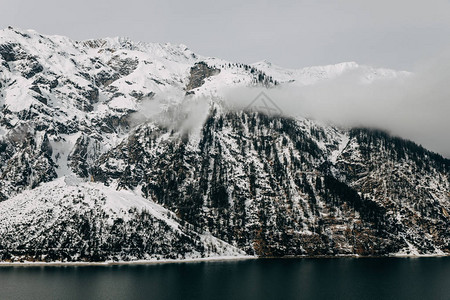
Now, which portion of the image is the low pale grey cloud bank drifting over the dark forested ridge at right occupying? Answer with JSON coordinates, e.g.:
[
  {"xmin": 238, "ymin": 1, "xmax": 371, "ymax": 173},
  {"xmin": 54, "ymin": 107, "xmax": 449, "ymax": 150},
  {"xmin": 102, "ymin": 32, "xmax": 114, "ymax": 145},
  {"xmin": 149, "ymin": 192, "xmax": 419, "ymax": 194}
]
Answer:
[{"xmin": 225, "ymin": 56, "xmax": 450, "ymax": 157}]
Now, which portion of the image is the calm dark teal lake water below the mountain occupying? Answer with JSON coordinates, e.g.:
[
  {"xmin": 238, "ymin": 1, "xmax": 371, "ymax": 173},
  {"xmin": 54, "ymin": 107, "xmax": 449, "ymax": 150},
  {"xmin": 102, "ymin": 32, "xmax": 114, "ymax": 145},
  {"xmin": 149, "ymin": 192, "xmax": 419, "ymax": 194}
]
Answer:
[{"xmin": 0, "ymin": 257, "xmax": 450, "ymax": 300}]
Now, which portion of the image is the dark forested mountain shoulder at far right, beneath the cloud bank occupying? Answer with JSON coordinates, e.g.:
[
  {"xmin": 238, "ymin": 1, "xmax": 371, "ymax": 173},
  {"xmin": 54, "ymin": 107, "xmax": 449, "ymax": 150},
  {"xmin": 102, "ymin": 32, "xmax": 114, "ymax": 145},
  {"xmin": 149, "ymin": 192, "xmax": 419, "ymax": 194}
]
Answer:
[{"xmin": 334, "ymin": 129, "xmax": 450, "ymax": 253}]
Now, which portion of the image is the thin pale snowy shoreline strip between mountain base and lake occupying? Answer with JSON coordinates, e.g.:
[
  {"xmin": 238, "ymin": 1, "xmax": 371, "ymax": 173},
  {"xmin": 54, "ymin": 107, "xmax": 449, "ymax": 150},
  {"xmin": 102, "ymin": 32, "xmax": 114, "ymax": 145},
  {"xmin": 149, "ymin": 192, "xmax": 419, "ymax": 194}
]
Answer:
[{"xmin": 0, "ymin": 254, "xmax": 450, "ymax": 268}]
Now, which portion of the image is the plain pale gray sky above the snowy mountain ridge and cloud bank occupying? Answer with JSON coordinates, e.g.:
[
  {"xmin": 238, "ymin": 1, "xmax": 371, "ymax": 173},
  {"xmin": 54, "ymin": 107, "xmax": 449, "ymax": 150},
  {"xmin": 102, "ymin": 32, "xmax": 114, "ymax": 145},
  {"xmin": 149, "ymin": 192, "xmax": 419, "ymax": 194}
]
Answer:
[{"xmin": 0, "ymin": 0, "xmax": 450, "ymax": 70}]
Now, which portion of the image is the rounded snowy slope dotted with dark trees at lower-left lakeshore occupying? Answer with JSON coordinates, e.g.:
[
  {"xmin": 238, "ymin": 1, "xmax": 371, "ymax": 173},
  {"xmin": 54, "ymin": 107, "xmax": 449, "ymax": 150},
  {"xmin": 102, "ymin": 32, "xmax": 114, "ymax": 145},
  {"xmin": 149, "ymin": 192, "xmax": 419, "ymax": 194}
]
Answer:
[{"xmin": 0, "ymin": 177, "xmax": 245, "ymax": 261}]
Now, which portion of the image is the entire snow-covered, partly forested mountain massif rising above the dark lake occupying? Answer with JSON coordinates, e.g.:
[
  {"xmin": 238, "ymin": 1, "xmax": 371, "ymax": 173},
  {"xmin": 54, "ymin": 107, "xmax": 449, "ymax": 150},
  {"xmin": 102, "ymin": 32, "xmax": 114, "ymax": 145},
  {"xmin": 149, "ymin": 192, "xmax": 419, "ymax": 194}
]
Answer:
[{"xmin": 0, "ymin": 28, "xmax": 450, "ymax": 261}]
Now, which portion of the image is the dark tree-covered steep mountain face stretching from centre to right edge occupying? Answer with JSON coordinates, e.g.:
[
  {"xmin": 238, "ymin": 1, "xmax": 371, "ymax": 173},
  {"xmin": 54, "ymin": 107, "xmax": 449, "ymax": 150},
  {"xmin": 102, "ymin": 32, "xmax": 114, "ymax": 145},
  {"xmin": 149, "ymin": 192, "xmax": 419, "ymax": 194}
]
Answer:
[{"xmin": 93, "ymin": 109, "xmax": 450, "ymax": 256}]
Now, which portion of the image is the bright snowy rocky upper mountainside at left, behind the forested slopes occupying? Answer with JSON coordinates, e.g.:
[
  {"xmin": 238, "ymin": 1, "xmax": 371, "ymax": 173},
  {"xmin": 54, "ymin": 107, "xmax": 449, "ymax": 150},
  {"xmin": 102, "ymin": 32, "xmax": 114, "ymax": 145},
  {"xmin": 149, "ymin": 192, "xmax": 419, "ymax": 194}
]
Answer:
[{"xmin": 0, "ymin": 28, "xmax": 278, "ymax": 200}]
